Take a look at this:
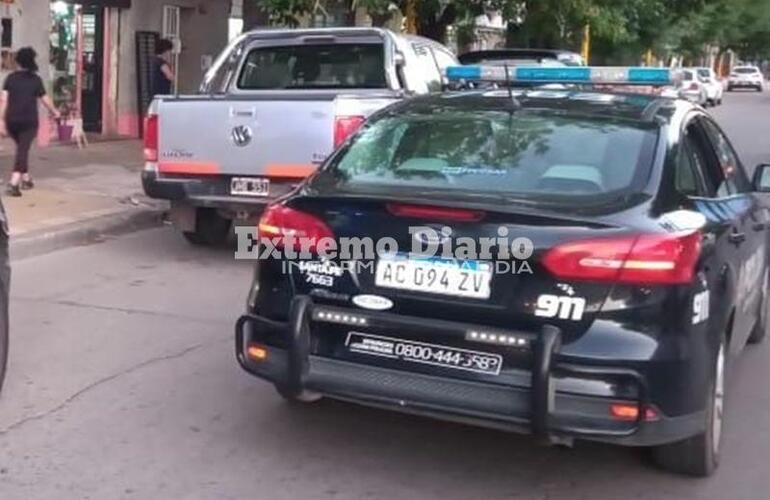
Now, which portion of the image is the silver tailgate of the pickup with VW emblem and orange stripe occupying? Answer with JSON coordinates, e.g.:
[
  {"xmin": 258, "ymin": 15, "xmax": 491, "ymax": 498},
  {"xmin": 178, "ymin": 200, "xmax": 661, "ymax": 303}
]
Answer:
[{"xmin": 158, "ymin": 90, "xmax": 397, "ymax": 178}]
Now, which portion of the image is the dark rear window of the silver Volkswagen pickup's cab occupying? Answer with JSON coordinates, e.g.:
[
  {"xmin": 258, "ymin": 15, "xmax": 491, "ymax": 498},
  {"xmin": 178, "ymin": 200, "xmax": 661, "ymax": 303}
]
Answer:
[{"xmin": 238, "ymin": 43, "xmax": 387, "ymax": 90}]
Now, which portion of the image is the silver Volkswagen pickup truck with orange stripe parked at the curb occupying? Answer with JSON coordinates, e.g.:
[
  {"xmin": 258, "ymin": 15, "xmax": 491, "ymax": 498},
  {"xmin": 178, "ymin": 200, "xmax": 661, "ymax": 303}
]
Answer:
[{"xmin": 142, "ymin": 28, "xmax": 457, "ymax": 245}]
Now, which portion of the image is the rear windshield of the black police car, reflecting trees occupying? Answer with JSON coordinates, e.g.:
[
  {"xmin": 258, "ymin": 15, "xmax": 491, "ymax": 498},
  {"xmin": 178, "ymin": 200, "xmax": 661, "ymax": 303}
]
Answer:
[{"xmin": 331, "ymin": 110, "xmax": 658, "ymax": 206}]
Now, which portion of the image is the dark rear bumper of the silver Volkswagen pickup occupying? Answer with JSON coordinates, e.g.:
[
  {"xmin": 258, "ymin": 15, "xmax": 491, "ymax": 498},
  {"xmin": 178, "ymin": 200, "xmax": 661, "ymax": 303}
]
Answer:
[{"xmin": 142, "ymin": 170, "xmax": 302, "ymax": 211}]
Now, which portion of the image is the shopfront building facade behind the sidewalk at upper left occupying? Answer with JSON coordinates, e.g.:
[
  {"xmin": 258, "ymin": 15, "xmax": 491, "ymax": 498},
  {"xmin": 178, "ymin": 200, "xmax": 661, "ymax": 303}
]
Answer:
[{"xmin": 0, "ymin": 0, "xmax": 230, "ymax": 145}]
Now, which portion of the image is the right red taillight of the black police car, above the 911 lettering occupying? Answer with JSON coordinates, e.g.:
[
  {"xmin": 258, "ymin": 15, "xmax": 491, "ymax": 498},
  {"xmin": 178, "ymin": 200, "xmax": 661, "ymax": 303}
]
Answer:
[{"xmin": 543, "ymin": 232, "xmax": 701, "ymax": 285}]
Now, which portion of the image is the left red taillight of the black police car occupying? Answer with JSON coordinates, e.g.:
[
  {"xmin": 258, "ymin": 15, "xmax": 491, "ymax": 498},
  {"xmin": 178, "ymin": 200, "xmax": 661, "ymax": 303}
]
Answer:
[{"xmin": 258, "ymin": 204, "xmax": 334, "ymax": 252}]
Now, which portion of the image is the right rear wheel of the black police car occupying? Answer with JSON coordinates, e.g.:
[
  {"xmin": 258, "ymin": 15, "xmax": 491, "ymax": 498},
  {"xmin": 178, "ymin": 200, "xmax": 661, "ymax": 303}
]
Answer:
[{"xmin": 652, "ymin": 339, "xmax": 727, "ymax": 477}]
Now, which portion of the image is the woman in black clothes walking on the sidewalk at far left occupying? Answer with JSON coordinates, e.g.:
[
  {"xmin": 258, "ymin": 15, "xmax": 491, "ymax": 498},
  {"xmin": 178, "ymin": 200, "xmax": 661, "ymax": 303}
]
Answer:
[{"xmin": 0, "ymin": 47, "xmax": 61, "ymax": 196}]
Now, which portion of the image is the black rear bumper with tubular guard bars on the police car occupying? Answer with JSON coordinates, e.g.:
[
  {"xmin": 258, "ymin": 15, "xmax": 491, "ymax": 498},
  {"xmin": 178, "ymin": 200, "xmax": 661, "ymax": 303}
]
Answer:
[{"xmin": 235, "ymin": 297, "xmax": 704, "ymax": 446}]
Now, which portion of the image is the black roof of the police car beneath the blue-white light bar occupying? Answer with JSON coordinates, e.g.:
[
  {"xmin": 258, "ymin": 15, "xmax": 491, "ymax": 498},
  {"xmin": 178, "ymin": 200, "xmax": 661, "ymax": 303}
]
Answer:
[{"xmin": 396, "ymin": 88, "xmax": 688, "ymax": 123}]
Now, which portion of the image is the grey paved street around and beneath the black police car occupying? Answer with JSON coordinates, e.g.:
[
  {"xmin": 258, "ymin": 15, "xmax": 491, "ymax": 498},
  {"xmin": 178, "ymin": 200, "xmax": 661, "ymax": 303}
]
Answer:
[{"xmin": 0, "ymin": 92, "xmax": 770, "ymax": 500}]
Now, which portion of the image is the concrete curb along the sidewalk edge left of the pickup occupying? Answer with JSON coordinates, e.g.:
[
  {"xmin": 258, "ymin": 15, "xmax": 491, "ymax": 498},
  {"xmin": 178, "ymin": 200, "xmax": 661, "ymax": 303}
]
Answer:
[{"xmin": 9, "ymin": 208, "xmax": 165, "ymax": 261}]
